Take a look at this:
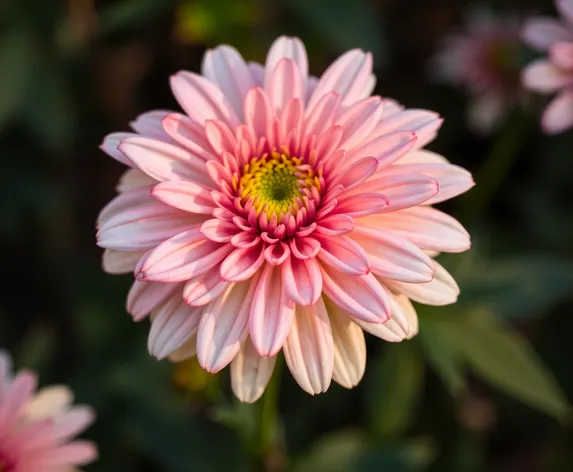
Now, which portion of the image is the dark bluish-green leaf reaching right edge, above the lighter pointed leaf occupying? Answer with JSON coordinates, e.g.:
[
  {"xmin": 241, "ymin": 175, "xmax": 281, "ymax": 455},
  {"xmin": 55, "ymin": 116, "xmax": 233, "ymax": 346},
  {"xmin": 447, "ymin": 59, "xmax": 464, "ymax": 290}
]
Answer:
[{"xmin": 459, "ymin": 256, "xmax": 573, "ymax": 318}]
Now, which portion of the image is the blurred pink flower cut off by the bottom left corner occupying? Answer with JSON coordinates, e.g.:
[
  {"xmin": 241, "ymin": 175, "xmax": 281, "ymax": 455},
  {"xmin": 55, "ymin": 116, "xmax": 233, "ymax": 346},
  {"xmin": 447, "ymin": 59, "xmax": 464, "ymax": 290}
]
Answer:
[{"xmin": 0, "ymin": 351, "xmax": 97, "ymax": 472}]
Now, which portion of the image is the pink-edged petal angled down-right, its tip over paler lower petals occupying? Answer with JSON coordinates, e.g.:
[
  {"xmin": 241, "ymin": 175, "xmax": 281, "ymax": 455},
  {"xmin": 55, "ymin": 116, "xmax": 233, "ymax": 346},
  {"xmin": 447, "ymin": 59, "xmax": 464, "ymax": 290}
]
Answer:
[{"xmin": 321, "ymin": 265, "xmax": 390, "ymax": 323}]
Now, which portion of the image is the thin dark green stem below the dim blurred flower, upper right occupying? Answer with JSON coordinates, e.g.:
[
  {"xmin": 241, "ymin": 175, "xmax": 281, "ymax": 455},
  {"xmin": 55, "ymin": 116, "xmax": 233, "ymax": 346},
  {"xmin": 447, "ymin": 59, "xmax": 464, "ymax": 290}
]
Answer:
[{"xmin": 461, "ymin": 111, "xmax": 531, "ymax": 225}]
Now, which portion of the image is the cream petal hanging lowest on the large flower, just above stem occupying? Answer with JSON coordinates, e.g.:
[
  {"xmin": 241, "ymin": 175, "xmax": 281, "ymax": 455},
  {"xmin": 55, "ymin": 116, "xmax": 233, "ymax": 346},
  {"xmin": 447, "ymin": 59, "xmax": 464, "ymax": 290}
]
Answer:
[{"xmin": 231, "ymin": 339, "xmax": 277, "ymax": 403}]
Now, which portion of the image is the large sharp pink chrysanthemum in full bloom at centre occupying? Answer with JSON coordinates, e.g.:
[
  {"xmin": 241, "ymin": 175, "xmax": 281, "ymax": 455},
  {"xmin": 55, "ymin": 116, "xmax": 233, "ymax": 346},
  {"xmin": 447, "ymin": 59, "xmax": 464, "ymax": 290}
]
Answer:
[{"xmin": 98, "ymin": 37, "xmax": 473, "ymax": 401}]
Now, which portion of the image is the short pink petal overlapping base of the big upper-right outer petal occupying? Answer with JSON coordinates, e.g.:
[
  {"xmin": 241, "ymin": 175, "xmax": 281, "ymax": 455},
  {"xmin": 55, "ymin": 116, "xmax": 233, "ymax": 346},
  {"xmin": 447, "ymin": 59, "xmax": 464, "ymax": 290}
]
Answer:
[{"xmin": 334, "ymin": 97, "xmax": 384, "ymax": 150}]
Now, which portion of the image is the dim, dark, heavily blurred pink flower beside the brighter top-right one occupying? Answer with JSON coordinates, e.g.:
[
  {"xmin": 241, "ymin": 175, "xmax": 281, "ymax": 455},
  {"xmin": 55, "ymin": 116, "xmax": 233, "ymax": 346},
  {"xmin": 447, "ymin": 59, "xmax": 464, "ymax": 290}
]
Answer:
[{"xmin": 431, "ymin": 8, "xmax": 521, "ymax": 133}]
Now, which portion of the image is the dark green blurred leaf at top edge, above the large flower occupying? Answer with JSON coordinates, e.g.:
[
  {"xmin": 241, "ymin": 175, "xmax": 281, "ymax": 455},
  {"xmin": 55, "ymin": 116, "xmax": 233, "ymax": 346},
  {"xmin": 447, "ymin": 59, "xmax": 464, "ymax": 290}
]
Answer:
[{"xmin": 287, "ymin": 0, "xmax": 384, "ymax": 63}]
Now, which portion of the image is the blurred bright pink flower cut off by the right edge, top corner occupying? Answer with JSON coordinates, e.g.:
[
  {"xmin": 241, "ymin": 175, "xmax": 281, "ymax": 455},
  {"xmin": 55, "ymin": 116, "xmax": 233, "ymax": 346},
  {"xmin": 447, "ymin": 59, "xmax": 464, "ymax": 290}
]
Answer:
[{"xmin": 522, "ymin": 0, "xmax": 573, "ymax": 134}]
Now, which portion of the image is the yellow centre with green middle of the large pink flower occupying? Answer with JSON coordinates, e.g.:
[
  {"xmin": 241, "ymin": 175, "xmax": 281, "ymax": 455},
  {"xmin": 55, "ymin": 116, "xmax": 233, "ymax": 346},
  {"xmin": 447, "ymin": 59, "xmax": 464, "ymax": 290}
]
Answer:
[{"xmin": 233, "ymin": 152, "xmax": 320, "ymax": 216}]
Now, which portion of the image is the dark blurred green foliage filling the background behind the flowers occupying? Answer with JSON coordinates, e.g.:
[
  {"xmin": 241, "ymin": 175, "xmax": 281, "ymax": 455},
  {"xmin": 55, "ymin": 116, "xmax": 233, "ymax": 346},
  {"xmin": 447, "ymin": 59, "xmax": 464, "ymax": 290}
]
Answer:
[{"xmin": 0, "ymin": 0, "xmax": 573, "ymax": 472}]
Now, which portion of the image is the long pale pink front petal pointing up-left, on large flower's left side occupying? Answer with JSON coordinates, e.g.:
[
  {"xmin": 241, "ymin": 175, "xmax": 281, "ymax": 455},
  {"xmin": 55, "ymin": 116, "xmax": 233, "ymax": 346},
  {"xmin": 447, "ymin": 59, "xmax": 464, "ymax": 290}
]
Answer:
[{"xmin": 119, "ymin": 137, "xmax": 210, "ymax": 186}]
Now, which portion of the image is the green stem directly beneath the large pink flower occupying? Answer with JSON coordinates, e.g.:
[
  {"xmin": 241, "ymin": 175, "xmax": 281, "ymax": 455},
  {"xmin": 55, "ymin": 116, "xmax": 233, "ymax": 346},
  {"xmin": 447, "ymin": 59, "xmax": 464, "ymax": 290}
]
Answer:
[{"xmin": 259, "ymin": 359, "xmax": 282, "ymax": 470}]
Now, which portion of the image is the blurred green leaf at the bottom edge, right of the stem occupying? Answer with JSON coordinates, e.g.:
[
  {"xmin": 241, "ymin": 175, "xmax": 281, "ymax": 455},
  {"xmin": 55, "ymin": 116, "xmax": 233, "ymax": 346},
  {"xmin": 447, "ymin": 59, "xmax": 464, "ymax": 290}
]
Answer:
[{"xmin": 292, "ymin": 430, "xmax": 367, "ymax": 472}]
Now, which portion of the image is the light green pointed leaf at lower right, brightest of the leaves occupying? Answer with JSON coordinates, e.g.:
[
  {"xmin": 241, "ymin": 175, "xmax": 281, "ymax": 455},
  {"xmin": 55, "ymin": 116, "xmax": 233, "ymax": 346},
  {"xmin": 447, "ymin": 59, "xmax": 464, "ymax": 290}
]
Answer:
[{"xmin": 424, "ymin": 311, "xmax": 570, "ymax": 419}]
